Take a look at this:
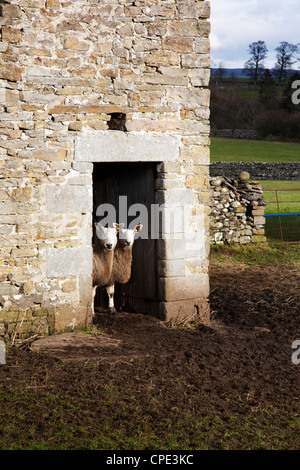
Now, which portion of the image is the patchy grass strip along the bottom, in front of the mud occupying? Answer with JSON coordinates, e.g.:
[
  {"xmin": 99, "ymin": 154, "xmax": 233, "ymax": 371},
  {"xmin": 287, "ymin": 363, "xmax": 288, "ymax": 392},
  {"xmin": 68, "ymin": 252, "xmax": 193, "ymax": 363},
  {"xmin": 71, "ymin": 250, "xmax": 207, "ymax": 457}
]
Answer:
[{"xmin": 0, "ymin": 376, "xmax": 296, "ymax": 450}]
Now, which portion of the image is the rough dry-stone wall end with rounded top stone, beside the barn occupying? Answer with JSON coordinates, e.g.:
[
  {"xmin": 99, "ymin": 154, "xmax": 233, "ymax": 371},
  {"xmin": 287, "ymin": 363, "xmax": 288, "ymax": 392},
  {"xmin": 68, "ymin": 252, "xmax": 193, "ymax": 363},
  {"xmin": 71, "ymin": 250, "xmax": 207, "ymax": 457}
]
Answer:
[{"xmin": 210, "ymin": 172, "xmax": 266, "ymax": 244}]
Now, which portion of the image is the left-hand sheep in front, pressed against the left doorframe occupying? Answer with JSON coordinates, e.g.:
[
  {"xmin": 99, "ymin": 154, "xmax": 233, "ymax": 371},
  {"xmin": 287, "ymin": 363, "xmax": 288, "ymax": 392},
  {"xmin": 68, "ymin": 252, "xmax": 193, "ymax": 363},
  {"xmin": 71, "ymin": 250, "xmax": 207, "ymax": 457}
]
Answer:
[{"xmin": 92, "ymin": 222, "xmax": 119, "ymax": 315}]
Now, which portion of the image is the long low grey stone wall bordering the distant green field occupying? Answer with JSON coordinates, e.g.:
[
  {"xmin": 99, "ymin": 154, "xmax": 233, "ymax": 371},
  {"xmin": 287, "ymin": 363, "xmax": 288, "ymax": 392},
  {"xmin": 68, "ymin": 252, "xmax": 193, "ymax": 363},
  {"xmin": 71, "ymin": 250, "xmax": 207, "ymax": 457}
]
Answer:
[{"xmin": 210, "ymin": 162, "xmax": 300, "ymax": 185}]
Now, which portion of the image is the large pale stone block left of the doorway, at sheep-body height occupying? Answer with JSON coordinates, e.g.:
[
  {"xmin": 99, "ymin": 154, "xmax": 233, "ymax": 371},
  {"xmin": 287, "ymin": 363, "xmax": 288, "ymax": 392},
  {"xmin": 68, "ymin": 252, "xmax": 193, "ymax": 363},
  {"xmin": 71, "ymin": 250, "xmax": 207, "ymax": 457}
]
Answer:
[{"xmin": 46, "ymin": 247, "xmax": 92, "ymax": 278}]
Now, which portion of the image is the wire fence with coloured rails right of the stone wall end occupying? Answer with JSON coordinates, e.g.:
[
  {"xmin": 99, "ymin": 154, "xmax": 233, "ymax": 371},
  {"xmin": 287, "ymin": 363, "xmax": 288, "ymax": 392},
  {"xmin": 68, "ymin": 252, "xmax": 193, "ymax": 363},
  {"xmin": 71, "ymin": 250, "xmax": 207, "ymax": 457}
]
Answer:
[{"xmin": 264, "ymin": 188, "xmax": 300, "ymax": 243}]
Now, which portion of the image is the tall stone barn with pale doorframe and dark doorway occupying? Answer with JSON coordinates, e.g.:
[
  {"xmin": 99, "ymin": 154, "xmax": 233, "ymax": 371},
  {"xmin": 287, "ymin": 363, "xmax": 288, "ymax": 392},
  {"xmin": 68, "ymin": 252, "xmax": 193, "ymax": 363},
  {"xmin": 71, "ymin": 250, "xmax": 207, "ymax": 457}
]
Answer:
[{"xmin": 0, "ymin": 0, "xmax": 210, "ymax": 338}]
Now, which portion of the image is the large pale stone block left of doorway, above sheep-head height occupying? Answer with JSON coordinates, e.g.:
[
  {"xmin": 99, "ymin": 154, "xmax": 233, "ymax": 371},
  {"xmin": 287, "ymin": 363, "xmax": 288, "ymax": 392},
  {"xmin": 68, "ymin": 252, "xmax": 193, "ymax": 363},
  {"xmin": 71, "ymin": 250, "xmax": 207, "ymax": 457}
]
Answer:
[{"xmin": 46, "ymin": 185, "xmax": 93, "ymax": 213}]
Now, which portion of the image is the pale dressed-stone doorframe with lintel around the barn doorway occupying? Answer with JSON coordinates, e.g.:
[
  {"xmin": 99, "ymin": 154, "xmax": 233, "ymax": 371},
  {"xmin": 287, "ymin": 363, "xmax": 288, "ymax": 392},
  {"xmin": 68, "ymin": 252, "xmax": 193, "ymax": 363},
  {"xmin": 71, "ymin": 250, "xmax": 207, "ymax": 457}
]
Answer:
[{"xmin": 47, "ymin": 130, "xmax": 209, "ymax": 320}]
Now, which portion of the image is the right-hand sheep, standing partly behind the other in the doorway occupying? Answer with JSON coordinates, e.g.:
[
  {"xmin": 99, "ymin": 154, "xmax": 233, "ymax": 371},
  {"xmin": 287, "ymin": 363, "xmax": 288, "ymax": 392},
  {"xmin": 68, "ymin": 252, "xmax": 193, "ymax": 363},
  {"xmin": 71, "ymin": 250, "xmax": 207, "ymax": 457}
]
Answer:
[{"xmin": 106, "ymin": 224, "xmax": 143, "ymax": 313}]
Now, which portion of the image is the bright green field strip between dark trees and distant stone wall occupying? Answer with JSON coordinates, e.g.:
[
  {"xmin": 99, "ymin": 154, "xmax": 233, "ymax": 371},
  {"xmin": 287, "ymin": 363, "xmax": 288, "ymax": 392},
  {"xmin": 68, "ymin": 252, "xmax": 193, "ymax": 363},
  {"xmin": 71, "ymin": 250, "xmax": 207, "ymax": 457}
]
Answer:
[{"xmin": 210, "ymin": 137, "xmax": 300, "ymax": 162}]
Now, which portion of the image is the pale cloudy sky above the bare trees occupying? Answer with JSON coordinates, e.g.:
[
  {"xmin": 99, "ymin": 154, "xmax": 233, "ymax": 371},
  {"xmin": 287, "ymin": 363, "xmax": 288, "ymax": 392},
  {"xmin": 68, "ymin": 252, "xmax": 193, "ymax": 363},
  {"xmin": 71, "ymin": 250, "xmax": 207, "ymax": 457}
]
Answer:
[{"xmin": 210, "ymin": 0, "xmax": 300, "ymax": 68}]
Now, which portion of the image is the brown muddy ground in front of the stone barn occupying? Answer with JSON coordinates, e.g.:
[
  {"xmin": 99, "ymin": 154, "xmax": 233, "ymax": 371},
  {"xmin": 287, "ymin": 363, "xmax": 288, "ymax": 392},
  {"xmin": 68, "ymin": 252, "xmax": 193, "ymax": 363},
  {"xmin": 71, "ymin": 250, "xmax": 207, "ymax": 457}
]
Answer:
[{"xmin": 0, "ymin": 267, "xmax": 300, "ymax": 450}]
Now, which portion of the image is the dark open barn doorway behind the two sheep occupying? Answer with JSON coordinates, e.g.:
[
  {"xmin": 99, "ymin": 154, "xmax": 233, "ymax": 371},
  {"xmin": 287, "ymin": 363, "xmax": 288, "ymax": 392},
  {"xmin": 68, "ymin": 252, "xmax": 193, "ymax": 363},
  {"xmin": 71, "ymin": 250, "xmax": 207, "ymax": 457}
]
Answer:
[{"xmin": 93, "ymin": 162, "xmax": 158, "ymax": 315}]
